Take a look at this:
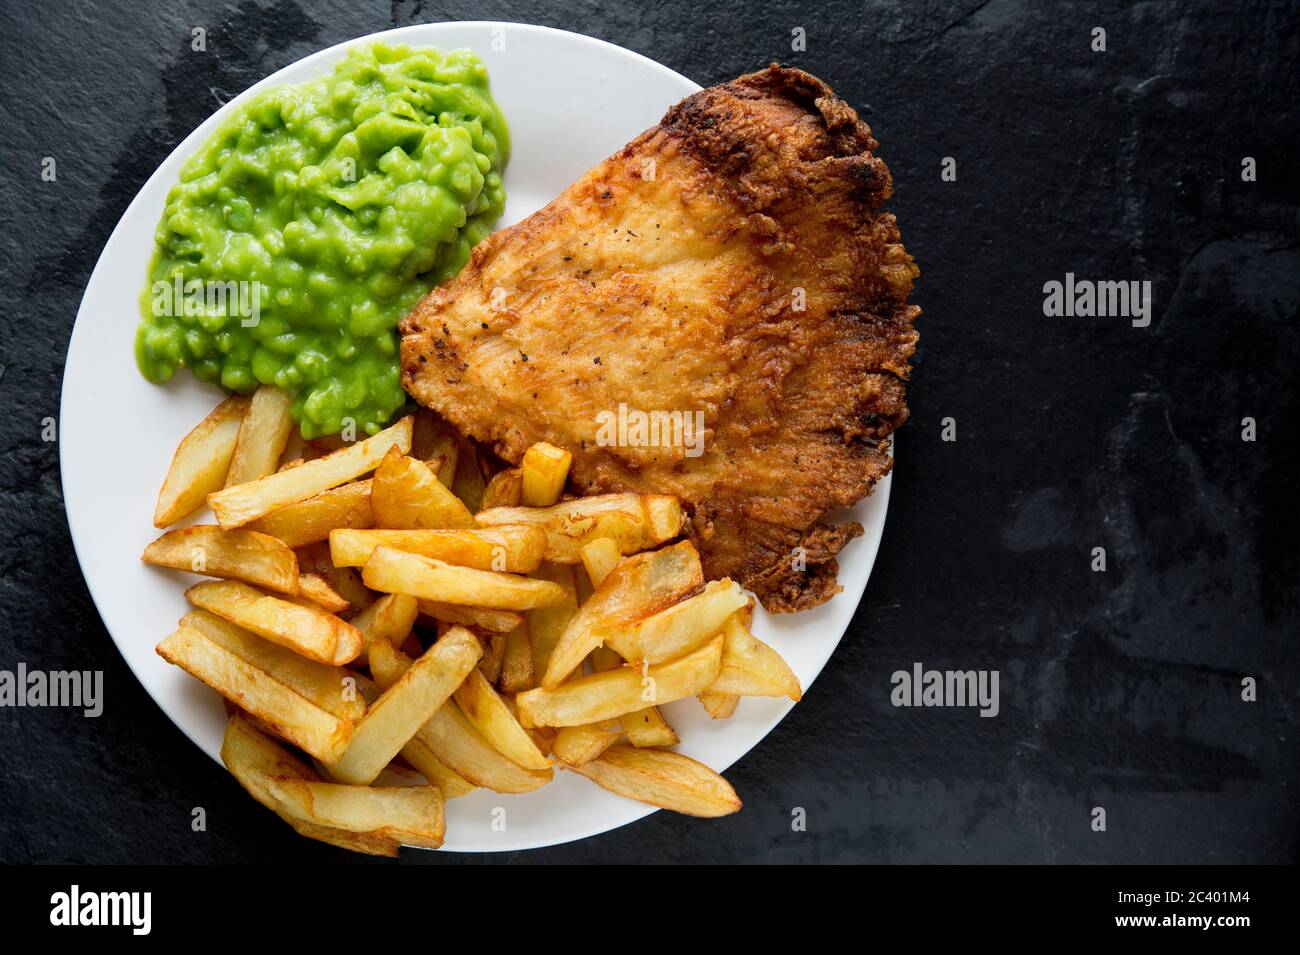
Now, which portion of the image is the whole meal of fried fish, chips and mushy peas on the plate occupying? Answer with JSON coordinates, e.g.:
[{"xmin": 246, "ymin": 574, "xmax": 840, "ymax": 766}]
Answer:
[{"xmin": 137, "ymin": 44, "xmax": 918, "ymax": 855}]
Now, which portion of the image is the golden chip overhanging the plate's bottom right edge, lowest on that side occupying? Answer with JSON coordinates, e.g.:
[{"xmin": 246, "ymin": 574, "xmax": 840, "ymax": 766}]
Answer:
[{"xmin": 572, "ymin": 746, "xmax": 741, "ymax": 817}]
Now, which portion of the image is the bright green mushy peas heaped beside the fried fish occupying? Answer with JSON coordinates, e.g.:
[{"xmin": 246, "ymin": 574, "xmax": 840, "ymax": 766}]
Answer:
[{"xmin": 135, "ymin": 43, "xmax": 510, "ymax": 438}]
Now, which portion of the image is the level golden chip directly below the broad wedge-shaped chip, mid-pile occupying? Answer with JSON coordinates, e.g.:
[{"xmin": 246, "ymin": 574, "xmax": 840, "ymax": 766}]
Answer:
[{"xmin": 329, "ymin": 525, "xmax": 546, "ymax": 573}]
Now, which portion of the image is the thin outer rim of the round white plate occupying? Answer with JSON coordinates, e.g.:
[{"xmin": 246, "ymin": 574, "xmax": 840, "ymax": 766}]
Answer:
[{"xmin": 59, "ymin": 19, "xmax": 894, "ymax": 854}]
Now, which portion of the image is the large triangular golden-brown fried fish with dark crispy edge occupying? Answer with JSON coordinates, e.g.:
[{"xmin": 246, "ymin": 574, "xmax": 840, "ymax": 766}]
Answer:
[{"xmin": 402, "ymin": 65, "xmax": 920, "ymax": 611}]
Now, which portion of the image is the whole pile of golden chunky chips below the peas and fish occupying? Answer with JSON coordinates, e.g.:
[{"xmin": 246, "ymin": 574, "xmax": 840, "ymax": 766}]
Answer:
[{"xmin": 143, "ymin": 387, "xmax": 800, "ymax": 855}]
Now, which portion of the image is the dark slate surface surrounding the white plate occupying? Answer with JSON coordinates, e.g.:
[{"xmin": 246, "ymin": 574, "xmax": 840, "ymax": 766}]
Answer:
[{"xmin": 0, "ymin": 0, "xmax": 1300, "ymax": 863}]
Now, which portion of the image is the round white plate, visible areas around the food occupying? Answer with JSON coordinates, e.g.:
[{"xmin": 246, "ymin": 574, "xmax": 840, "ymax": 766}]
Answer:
[{"xmin": 60, "ymin": 22, "xmax": 889, "ymax": 852}]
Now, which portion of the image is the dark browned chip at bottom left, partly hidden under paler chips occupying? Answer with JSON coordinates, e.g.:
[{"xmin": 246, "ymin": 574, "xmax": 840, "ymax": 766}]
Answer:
[{"xmin": 221, "ymin": 713, "xmax": 400, "ymax": 856}]
